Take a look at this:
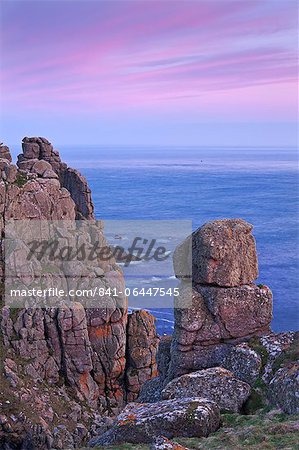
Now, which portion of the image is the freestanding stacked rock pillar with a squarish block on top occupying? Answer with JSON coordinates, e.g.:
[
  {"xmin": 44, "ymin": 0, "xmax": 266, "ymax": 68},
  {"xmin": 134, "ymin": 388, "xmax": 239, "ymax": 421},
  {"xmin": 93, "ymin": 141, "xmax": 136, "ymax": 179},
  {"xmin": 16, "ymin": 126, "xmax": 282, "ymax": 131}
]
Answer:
[{"xmin": 168, "ymin": 219, "xmax": 272, "ymax": 381}]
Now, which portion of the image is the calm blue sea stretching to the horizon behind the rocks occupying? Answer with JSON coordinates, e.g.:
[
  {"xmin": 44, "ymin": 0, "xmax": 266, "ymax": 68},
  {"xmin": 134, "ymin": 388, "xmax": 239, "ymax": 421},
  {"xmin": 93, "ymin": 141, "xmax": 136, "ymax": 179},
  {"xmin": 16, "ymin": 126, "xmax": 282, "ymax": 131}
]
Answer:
[{"xmin": 60, "ymin": 147, "xmax": 299, "ymax": 333}]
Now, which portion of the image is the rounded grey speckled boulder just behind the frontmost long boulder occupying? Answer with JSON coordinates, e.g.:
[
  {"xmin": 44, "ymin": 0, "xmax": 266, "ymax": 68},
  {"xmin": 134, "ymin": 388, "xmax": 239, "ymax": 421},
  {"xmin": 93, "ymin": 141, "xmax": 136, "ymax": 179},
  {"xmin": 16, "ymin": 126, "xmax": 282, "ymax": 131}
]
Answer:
[{"xmin": 162, "ymin": 367, "xmax": 250, "ymax": 412}]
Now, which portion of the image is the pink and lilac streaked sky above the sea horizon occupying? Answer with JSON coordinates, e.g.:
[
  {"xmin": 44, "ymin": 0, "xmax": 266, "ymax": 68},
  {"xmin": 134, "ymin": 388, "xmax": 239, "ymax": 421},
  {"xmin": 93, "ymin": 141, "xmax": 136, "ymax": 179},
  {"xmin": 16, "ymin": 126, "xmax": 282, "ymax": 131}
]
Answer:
[{"xmin": 1, "ymin": 0, "xmax": 297, "ymax": 145}]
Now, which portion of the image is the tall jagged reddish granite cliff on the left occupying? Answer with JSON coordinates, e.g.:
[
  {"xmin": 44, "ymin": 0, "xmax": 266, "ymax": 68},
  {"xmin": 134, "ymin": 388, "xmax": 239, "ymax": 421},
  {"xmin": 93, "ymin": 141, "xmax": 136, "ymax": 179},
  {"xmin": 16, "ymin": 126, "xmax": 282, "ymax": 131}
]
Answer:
[{"xmin": 0, "ymin": 138, "xmax": 157, "ymax": 449}]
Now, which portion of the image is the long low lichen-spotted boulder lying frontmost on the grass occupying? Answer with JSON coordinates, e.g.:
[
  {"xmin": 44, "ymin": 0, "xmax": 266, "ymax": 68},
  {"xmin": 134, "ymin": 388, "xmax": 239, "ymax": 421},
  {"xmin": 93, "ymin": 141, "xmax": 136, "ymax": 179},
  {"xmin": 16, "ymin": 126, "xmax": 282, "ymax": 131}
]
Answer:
[{"xmin": 89, "ymin": 397, "xmax": 220, "ymax": 447}]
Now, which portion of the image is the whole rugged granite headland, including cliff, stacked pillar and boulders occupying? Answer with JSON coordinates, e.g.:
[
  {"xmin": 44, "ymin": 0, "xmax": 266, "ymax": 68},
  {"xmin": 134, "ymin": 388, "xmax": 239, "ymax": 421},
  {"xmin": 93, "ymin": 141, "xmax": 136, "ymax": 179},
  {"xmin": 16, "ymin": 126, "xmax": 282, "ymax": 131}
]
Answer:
[{"xmin": 0, "ymin": 138, "xmax": 299, "ymax": 450}]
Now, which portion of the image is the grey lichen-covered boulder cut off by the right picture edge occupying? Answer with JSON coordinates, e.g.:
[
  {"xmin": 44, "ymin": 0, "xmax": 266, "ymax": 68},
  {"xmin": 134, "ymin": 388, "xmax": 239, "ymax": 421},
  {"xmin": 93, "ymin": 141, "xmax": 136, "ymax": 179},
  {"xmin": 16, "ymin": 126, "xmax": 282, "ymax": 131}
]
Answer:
[{"xmin": 268, "ymin": 361, "xmax": 299, "ymax": 414}]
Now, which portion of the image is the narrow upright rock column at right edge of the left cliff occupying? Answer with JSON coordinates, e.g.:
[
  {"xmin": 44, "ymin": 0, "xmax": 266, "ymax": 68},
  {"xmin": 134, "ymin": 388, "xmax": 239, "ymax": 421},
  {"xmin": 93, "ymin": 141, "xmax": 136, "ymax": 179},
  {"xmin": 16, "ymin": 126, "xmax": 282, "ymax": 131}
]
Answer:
[{"xmin": 126, "ymin": 311, "xmax": 159, "ymax": 402}]
